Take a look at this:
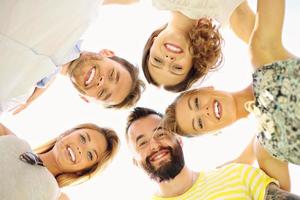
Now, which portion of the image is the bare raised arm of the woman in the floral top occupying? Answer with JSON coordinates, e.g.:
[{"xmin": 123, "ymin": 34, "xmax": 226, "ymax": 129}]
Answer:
[{"xmin": 249, "ymin": 0, "xmax": 294, "ymax": 68}]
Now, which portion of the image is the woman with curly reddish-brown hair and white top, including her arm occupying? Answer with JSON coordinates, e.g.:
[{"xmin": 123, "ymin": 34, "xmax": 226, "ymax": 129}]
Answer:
[{"xmin": 142, "ymin": 0, "xmax": 254, "ymax": 92}]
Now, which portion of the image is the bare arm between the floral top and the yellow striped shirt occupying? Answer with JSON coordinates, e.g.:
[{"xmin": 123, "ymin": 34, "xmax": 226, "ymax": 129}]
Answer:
[{"xmin": 254, "ymin": 140, "xmax": 291, "ymax": 191}]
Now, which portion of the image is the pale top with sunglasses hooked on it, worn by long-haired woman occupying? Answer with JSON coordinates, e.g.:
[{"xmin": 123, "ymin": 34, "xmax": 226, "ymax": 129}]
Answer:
[{"xmin": 0, "ymin": 135, "xmax": 60, "ymax": 200}]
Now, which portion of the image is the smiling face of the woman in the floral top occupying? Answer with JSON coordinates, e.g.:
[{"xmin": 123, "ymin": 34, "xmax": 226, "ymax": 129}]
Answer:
[{"xmin": 175, "ymin": 87, "xmax": 237, "ymax": 135}]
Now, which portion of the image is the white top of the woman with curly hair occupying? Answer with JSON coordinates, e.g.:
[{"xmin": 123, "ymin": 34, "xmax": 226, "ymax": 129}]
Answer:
[{"xmin": 152, "ymin": 0, "xmax": 245, "ymax": 26}]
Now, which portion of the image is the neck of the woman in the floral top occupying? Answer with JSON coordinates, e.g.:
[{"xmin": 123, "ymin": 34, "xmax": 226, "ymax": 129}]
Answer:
[{"xmin": 233, "ymin": 84, "xmax": 254, "ymax": 119}]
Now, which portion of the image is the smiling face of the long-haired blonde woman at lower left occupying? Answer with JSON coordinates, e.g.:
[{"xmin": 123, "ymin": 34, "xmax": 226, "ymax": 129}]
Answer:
[{"xmin": 53, "ymin": 128, "xmax": 107, "ymax": 172}]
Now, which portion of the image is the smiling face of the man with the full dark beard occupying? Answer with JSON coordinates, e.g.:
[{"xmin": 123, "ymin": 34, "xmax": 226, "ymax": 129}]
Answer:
[{"xmin": 128, "ymin": 115, "xmax": 184, "ymax": 182}]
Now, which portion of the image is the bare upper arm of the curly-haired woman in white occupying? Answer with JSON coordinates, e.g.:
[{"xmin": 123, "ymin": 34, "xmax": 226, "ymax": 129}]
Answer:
[{"xmin": 230, "ymin": 1, "xmax": 255, "ymax": 44}]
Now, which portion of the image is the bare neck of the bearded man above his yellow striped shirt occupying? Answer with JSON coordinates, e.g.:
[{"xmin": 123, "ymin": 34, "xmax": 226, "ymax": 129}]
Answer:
[{"xmin": 157, "ymin": 166, "xmax": 198, "ymax": 197}]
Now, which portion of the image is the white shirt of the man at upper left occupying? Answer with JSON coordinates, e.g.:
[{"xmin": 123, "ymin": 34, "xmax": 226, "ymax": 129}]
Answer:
[{"xmin": 0, "ymin": 0, "xmax": 102, "ymax": 113}]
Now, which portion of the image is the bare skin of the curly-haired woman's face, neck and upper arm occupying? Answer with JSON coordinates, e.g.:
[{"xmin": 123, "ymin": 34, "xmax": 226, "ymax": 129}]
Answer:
[{"xmin": 148, "ymin": 1, "xmax": 255, "ymax": 86}]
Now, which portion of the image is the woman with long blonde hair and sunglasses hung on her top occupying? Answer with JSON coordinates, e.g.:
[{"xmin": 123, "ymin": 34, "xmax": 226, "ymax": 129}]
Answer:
[{"xmin": 0, "ymin": 124, "xmax": 119, "ymax": 200}]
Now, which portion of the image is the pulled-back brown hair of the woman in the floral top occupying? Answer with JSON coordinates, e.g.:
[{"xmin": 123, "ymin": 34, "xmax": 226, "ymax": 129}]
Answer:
[{"xmin": 163, "ymin": 89, "xmax": 197, "ymax": 137}]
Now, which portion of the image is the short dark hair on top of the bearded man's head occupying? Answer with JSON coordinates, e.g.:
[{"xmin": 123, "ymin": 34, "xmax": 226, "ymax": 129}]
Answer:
[{"xmin": 125, "ymin": 107, "xmax": 163, "ymax": 138}]
